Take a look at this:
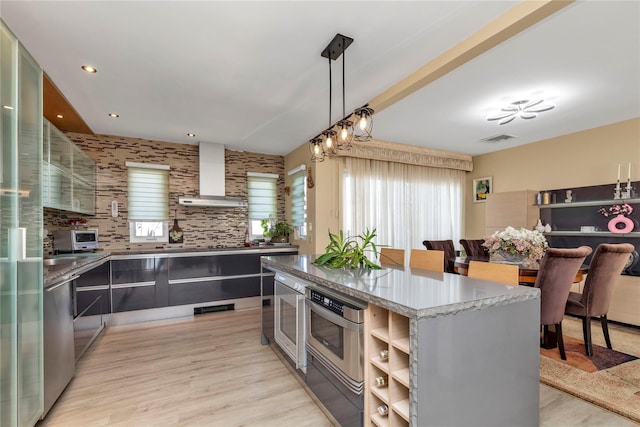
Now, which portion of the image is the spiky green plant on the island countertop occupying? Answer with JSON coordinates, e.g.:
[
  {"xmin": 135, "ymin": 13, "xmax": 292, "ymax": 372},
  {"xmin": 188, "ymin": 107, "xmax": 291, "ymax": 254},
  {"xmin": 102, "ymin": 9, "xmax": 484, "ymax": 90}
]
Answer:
[{"xmin": 314, "ymin": 228, "xmax": 381, "ymax": 270}]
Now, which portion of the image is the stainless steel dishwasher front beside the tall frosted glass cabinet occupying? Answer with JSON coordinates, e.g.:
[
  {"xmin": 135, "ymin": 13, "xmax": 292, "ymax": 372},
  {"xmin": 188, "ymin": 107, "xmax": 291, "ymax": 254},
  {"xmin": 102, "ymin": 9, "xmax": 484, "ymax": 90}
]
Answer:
[{"xmin": 42, "ymin": 275, "xmax": 78, "ymax": 418}]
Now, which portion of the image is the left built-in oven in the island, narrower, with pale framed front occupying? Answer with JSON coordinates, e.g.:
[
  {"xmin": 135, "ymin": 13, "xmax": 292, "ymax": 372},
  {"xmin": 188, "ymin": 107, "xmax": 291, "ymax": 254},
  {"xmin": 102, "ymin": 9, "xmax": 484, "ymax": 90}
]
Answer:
[{"xmin": 273, "ymin": 272, "xmax": 307, "ymax": 373}]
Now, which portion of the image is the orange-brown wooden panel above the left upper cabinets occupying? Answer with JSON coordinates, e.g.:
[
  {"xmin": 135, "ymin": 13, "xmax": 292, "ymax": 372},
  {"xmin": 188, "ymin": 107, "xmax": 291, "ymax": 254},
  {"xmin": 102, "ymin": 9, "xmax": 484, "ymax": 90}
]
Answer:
[{"xmin": 42, "ymin": 74, "xmax": 93, "ymax": 135}]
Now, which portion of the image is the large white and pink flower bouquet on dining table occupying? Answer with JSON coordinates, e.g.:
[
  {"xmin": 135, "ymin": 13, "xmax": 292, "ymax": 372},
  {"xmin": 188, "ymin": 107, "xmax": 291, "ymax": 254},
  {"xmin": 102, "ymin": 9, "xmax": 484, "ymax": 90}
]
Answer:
[{"xmin": 483, "ymin": 227, "xmax": 549, "ymax": 263}]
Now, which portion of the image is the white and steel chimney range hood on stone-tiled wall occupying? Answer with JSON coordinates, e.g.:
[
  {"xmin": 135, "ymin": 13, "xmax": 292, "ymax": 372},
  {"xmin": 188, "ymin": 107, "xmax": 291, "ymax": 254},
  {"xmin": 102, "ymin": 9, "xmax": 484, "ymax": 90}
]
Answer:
[{"xmin": 178, "ymin": 142, "xmax": 248, "ymax": 208}]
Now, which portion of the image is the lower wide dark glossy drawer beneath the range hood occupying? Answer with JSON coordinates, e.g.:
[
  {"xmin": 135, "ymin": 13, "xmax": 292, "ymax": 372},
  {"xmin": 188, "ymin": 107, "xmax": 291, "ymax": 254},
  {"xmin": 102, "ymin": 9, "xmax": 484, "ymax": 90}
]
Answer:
[{"xmin": 169, "ymin": 276, "xmax": 260, "ymax": 305}]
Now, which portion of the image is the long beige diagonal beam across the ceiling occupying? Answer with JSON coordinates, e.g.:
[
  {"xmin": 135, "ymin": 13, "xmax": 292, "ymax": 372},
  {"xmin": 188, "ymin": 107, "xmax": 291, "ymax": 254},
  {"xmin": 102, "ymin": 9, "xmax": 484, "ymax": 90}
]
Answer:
[{"xmin": 369, "ymin": 0, "xmax": 575, "ymax": 113}]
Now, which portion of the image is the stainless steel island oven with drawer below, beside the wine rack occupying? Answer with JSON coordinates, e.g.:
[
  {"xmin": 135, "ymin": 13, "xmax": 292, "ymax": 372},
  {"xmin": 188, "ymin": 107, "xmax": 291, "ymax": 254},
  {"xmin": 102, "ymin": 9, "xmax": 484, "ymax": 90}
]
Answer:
[{"xmin": 306, "ymin": 285, "xmax": 367, "ymax": 427}]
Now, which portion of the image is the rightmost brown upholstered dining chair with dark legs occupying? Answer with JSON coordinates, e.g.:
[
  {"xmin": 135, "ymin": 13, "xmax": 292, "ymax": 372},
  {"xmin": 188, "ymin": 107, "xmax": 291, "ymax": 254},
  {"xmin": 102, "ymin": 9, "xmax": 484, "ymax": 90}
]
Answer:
[{"xmin": 565, "ymin": 243, "xmax": 634, "ymax": 357}]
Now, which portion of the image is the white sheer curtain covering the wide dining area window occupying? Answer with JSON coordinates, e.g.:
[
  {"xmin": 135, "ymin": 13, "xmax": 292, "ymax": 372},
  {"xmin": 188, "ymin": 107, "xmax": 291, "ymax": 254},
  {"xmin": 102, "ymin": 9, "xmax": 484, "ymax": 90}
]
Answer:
[{"xmin": 343, "ymin": 157, "xmax": 465, "ymax": 251}]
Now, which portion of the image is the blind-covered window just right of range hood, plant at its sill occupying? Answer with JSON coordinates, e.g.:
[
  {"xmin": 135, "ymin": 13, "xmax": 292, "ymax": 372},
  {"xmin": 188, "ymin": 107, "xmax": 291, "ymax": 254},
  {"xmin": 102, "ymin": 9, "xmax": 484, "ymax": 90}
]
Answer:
[{"xmin": 247, "ymin": 172, "xmax": 278, "ymax": 239}]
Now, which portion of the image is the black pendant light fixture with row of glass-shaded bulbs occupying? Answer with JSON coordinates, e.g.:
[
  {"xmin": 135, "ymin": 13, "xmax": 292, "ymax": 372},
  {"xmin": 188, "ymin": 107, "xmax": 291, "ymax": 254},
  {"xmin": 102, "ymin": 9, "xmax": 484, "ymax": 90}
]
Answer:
[{"xmin": 309, "ymin": 34, "xmax": 373, "ymax": 162}]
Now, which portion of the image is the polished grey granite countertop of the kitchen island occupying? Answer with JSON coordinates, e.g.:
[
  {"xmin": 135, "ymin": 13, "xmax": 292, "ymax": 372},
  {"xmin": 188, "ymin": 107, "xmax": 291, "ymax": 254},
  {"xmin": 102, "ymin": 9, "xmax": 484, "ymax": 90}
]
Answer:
[{"xmin": 262, "ymin": 255, "xmax": 540, "ymax": 319}]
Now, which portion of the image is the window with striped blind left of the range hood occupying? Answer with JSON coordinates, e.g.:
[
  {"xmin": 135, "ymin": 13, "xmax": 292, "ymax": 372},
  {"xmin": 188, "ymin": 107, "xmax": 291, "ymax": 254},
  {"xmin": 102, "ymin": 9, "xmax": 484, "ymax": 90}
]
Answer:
[{"xmin": 126, "ymin": 162, "xmax": 169, "ymax": 243}]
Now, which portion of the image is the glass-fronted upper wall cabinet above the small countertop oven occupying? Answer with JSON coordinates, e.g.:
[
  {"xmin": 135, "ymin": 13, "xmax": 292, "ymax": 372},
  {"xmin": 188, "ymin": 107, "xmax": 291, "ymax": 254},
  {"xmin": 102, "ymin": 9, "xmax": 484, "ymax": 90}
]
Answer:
[{"xmin": 42, "ymin": 119, "xmax": 96, "ymax": 215}]
